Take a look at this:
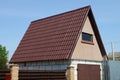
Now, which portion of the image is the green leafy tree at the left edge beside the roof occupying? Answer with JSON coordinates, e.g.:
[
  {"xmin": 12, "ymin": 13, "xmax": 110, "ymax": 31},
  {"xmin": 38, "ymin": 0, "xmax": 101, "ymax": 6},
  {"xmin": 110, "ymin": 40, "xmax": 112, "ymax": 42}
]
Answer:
[{"xmin": 0, "ymin": 45, "xmax": 8, "ymax": 69}]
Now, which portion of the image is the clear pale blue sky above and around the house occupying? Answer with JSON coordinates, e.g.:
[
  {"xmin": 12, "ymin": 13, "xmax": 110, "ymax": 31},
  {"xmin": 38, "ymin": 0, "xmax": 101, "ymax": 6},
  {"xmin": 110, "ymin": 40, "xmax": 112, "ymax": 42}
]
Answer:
[{"xmin": 0, "ymin": 0, "xmax": 120, "ymax": 59}]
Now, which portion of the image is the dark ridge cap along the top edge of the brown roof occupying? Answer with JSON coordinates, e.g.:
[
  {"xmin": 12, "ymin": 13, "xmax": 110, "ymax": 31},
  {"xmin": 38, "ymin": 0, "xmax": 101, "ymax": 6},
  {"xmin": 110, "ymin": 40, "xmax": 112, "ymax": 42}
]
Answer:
[{"xmin": 31, "ymin": 5, "xmax": 91, "ymax": 23}]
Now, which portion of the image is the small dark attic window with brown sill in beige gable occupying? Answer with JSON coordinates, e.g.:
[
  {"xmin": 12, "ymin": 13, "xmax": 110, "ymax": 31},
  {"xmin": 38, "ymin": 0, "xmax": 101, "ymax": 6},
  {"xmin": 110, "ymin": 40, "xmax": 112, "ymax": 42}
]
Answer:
[{"xmin": 82, "ymin": 32, "xmax": 93, "ymax": 44}]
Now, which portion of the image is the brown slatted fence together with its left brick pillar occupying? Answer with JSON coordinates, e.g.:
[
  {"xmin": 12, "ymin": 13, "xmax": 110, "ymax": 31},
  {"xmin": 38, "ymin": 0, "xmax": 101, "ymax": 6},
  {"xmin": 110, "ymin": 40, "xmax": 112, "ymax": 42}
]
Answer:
[{"xmin": 0, "ymin": 65, "xmax": 67, "ymax": 80}]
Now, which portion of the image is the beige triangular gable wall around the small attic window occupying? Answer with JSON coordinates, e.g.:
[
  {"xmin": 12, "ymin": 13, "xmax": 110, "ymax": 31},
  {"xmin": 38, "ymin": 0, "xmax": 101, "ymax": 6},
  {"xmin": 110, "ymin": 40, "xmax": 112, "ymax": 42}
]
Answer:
[{"xmin": 72, "ymin": 17, "xmax": 103, "ymax": 61}]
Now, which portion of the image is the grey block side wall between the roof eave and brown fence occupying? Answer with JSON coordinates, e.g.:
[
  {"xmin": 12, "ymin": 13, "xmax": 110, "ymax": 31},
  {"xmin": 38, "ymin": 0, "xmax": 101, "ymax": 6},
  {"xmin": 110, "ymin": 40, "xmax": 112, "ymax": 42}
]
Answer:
[{"xmin": 18, "ymin": 60, "xmax": 70, "ymax": 70}]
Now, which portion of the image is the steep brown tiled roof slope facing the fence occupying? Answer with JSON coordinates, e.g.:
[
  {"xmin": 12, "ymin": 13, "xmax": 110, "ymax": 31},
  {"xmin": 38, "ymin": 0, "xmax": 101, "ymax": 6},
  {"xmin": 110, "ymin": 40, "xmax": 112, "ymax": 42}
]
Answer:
[{"xmin": 10, "ymin": 6, "xmax": 106, "ymax": 62}]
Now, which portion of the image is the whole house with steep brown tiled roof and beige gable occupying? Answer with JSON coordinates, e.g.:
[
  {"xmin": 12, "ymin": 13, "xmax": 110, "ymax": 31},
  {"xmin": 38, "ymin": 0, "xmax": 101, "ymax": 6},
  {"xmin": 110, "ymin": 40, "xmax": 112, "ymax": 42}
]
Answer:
[{"xmin": 10, "ymin": 6, "xmax": 107, "ymax": 80}]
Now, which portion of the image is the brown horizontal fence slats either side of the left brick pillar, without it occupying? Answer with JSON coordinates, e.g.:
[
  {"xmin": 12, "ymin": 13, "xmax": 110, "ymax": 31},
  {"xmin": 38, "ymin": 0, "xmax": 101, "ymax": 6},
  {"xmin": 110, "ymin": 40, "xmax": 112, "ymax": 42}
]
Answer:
[{"xmin": 0, "ymin": 70, "xmax": 66, "ymax": 80}]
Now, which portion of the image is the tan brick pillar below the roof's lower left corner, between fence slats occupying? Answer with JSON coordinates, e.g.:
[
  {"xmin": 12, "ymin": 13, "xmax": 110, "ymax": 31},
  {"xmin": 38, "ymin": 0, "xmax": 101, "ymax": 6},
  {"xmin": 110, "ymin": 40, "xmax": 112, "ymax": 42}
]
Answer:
[{"xmin": 10, "ymin": 64, "xmax": 19, "ymax": 80}]
